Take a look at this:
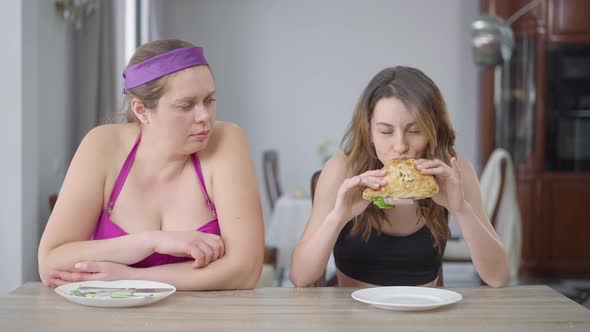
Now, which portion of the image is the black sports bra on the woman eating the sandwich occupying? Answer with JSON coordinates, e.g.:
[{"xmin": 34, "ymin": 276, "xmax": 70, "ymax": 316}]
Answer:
[{"xmin": 334, "ymin": 222, "xmax": 446, "ymax": 286}]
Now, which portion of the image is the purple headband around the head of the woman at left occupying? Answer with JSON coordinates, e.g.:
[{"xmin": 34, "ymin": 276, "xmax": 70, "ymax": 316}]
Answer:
[{"xmin": 123, "ymin": 46, "xmax": 208, "ymax": 94}]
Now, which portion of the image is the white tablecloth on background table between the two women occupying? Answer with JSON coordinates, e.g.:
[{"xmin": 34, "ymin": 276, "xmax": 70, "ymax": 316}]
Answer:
[{"xmin": 265, "ymin": 195, "xmax": 336, "ymax": 286}]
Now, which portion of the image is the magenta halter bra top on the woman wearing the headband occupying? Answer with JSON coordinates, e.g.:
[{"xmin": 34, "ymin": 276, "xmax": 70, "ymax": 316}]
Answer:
[{"xmin": 92, "ymin": 132, "xmax": 221, "ymax": 267}]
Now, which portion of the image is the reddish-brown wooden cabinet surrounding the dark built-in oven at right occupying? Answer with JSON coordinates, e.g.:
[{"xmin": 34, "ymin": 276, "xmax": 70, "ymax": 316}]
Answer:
[{"xmin": 480, "ymin": 0, "xmax": 590, "ymax": 278}]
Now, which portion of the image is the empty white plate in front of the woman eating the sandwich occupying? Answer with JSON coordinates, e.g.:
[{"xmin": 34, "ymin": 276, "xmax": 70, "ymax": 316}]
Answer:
[{"xmin": 352, "ymin": 286, "xmax": 463, "ymax": 311}]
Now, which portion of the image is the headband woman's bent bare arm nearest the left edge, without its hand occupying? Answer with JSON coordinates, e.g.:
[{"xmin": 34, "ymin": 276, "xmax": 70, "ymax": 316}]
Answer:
[{"xmin": 38, "ymin": 125, "xmax": 154, "ymax": 281}]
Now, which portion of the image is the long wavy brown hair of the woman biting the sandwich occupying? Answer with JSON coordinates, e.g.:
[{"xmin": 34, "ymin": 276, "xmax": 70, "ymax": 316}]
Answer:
[{"xmin": 341, "ymin": 67, "xmax": 456, "ymax": 251}]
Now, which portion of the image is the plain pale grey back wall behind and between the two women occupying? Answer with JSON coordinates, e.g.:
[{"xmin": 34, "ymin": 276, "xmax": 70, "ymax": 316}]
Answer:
[{"xmin": 162, "ymin": 0, "xmax": 478, "ymax": 220}]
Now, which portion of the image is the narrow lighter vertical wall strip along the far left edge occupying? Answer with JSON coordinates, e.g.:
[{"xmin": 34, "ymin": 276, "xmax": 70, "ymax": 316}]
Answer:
[{"xmin": 0, "ymin": 1, "xmax": 23, "ymax": 295}]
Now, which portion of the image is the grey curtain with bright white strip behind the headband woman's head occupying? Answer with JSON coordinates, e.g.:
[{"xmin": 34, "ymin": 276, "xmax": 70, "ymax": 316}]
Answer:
[{"xmin": 69, "ymin": 0, "xmax": 164, "ymax": 155}]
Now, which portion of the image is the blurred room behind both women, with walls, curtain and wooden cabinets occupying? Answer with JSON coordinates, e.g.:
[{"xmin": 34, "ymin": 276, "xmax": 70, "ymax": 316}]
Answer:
[{"xmin": 0, "ymin": 0, "xmax": 590, "ymax": 303}]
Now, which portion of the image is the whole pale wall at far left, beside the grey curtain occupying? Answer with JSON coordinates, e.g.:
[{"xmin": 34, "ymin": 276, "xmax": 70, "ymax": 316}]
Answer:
[{"xmin": 0, "ymin": 0, "xmax": 70, "ymax": 294}]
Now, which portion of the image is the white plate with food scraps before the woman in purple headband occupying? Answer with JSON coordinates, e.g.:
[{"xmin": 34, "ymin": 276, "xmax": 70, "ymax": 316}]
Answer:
[{"xmin": 55, "ymin": 280, "xmax": 176, "ymax": 308}]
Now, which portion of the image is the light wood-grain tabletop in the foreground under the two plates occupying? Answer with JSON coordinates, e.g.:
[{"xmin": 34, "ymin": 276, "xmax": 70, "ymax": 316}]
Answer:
[{"xmin": 0, "ymin": 283, "xmax": 590, "ymax": 332}]
